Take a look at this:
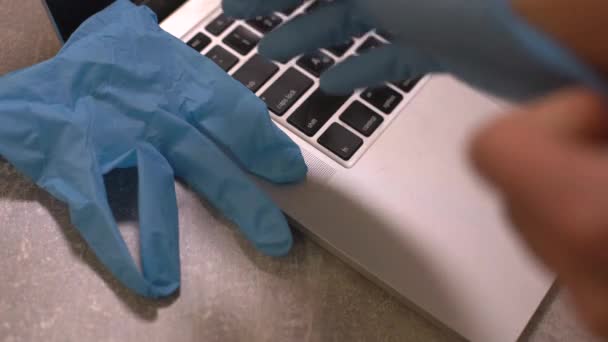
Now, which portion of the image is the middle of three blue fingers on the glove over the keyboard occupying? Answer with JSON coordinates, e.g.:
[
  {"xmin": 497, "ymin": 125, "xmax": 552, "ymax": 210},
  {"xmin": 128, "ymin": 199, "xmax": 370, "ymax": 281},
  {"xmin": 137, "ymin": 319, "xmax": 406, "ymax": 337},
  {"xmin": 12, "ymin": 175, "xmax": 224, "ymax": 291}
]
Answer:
[{"xmin": 259, "ymin": 2, "xmax": 371, "ymax": 61}]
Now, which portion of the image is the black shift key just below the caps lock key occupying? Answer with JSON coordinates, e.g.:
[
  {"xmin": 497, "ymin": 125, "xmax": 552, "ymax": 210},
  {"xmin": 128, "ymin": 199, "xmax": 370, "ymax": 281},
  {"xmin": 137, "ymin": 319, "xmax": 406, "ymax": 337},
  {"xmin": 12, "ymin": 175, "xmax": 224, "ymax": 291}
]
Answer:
[{"xmin": 287, "ymin": 90, "xmax": 350, "ymax": 137}]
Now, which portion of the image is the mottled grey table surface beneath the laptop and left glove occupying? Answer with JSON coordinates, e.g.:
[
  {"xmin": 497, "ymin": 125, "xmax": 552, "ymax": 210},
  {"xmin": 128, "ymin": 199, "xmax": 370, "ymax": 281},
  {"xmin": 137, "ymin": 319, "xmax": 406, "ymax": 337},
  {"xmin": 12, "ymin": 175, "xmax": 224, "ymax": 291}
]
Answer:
[{"xmin": 0, "ymin": 0, "xmax": 591, "ymax": 342}]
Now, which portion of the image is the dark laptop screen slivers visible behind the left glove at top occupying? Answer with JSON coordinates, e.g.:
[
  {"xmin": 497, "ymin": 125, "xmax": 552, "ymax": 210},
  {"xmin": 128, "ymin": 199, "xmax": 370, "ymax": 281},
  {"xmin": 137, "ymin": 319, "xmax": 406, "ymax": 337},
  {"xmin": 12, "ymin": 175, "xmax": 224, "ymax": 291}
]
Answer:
[{"xmin": 45, "ymin": 0, "xmax": 186, "ymax": 41}]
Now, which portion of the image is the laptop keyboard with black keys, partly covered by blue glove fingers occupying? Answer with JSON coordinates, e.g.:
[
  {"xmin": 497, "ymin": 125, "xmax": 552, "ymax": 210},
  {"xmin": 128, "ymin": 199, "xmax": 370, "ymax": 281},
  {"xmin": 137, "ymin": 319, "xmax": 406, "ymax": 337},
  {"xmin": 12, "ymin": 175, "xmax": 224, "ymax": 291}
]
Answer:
[{"xmin": 185, "ymin": 0, "xmax": 421, "ymax": 168}]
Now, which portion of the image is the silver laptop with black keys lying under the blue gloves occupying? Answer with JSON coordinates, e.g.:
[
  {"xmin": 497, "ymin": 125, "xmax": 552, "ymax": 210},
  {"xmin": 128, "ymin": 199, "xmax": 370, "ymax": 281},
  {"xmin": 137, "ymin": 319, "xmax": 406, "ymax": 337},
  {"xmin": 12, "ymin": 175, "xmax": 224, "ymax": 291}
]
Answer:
[{"xmin": 46, "ymin": 0, "xmax": 554, "ymax": 341}]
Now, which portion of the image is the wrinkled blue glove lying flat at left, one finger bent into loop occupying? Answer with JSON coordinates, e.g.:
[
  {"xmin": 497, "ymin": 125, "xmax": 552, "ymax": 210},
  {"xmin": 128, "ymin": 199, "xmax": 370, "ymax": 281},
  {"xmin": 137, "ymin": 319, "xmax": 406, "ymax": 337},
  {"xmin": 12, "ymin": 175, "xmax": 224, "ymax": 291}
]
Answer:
[{"xmin": 0, "ymin": 0, "xmax": 306, "ymax": 297}]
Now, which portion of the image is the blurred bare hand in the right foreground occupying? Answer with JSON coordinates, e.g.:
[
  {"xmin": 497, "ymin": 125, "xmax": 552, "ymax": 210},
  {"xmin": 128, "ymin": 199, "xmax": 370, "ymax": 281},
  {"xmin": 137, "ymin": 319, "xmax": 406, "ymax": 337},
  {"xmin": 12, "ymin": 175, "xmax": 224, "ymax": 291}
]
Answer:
[{"xmin": 472, "ymin": 89, "xmax": 608, "ymax": 337}]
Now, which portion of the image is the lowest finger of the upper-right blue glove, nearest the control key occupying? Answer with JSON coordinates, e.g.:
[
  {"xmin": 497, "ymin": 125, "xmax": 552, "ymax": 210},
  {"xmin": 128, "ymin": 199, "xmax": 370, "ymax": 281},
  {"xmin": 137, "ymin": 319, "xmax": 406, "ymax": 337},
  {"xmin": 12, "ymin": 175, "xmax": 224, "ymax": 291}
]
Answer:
[{"xmin": 321, "ymin": 45, "xmax": 441, "ymax": 94}]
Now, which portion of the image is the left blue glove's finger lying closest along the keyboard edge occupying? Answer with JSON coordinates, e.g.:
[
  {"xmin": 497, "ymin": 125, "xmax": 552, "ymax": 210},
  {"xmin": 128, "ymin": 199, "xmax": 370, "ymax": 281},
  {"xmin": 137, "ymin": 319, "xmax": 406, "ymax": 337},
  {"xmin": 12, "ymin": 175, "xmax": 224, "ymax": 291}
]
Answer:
[{"xmin": 179, "ymin": 54, "xmax": 308, "ymax": 183}]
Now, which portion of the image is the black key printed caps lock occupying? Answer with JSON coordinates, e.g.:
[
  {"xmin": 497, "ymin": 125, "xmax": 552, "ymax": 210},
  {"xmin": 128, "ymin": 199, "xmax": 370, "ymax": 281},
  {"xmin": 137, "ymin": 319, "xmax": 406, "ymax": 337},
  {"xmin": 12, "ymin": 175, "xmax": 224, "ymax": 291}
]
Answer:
[{"xmin": 260, "ymin": 68, "xmax": 314, "ymax": 116}]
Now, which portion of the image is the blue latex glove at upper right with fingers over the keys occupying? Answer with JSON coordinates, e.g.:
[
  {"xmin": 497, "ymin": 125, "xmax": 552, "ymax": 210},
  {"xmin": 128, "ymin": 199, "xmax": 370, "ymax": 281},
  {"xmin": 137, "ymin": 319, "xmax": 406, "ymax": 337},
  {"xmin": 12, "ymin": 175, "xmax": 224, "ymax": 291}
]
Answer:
[{"xmin": 223, "ymin": 0, "xmax": 606, "ymax": 100}]
